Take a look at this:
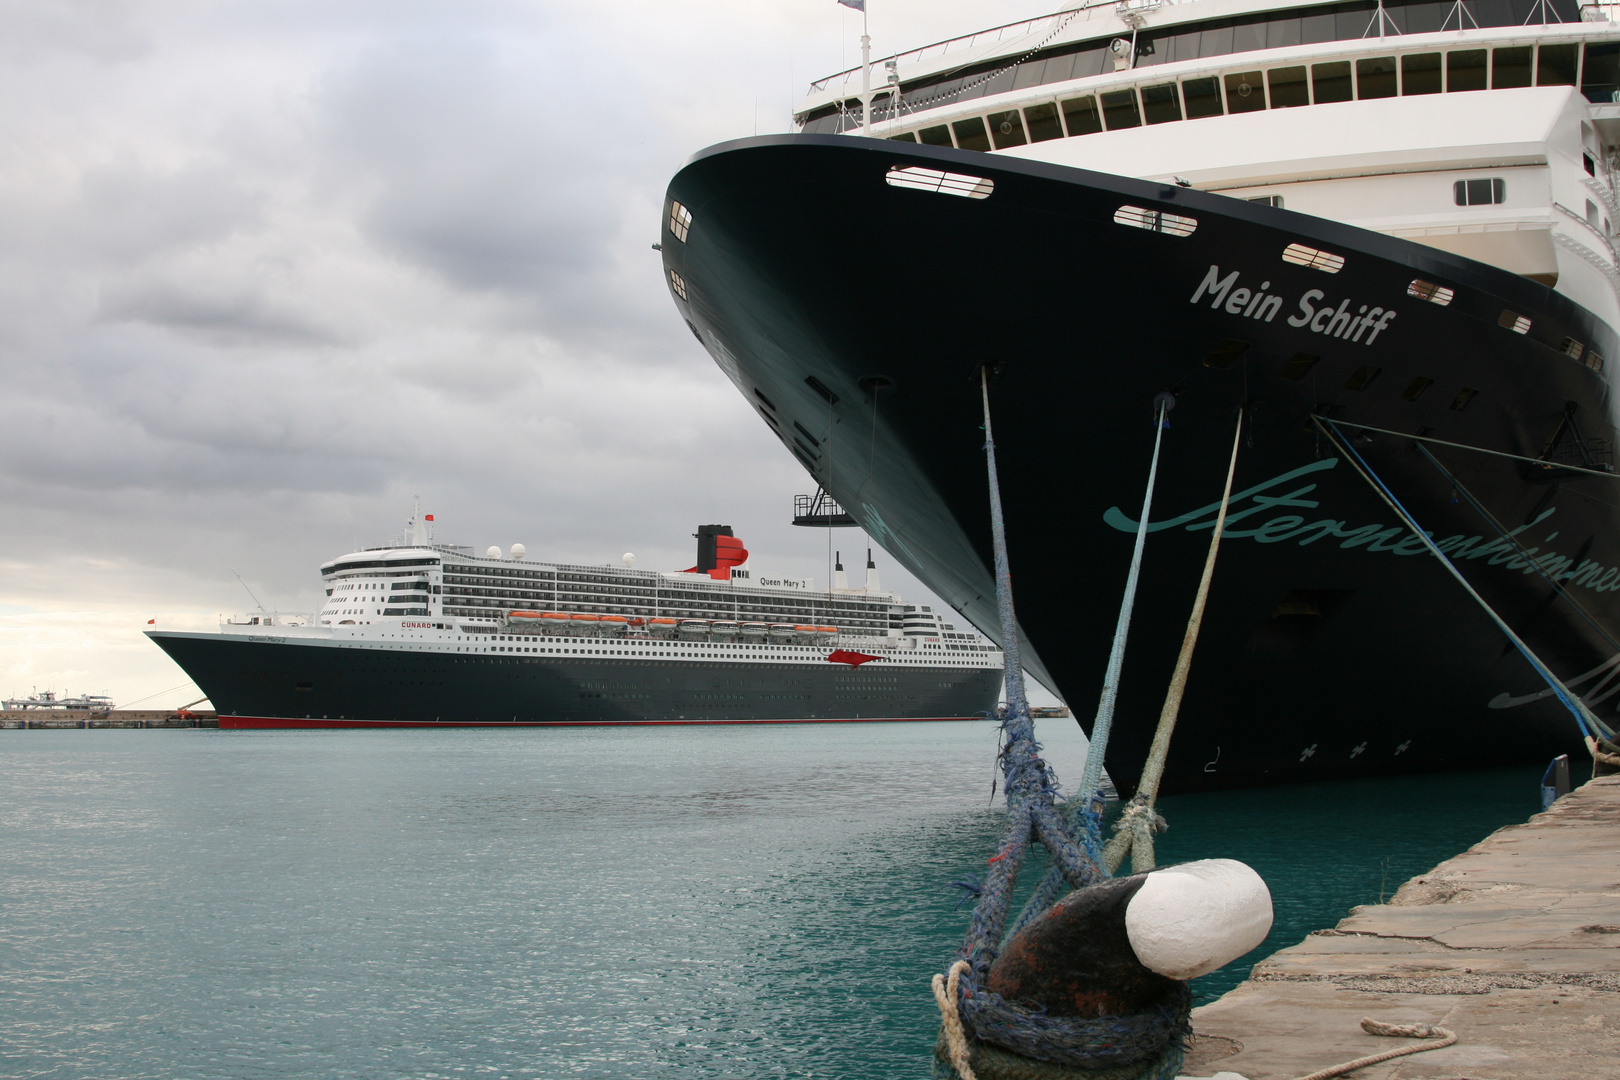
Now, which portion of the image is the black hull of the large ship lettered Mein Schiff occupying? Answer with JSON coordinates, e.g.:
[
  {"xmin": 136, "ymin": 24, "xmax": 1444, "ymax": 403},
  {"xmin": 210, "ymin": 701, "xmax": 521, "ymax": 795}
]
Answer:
[{"xmin": 663, "ymin": 136, "xmax": 1620, "ymax": 792}]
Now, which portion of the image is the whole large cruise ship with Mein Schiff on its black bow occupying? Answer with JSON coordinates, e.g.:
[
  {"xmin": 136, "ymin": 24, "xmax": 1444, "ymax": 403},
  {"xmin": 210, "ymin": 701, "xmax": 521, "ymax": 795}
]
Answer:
[{"xmin": 661, "ymin": 0, "xmax": 1620, "ymax": 790}]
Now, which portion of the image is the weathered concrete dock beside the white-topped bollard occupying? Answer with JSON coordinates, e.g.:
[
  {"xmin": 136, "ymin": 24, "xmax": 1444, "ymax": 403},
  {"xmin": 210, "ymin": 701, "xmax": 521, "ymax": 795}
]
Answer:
[{"xmin": 1181, "ymin": 776, "xmax": 1620, "ymax": 1080}]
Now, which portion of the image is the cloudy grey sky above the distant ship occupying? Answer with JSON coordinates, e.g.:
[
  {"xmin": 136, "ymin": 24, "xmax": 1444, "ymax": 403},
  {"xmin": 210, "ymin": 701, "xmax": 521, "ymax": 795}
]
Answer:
[{"xmin": 0, "ymin": 0, "xmax": 1056, "ymax": 708}]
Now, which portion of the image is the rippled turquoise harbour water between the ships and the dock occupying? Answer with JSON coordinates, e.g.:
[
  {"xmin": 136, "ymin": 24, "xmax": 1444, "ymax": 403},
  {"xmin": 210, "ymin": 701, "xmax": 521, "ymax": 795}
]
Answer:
[{"xmin": 0, "ymin": 722, "xmax": 1541, "ymax": 1080}]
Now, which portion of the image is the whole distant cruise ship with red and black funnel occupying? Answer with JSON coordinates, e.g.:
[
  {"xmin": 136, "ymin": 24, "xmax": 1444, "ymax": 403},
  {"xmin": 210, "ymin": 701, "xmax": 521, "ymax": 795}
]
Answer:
[{"xmin": 147, "ymin": 510, "xmax": 1003, "ymax": 727}]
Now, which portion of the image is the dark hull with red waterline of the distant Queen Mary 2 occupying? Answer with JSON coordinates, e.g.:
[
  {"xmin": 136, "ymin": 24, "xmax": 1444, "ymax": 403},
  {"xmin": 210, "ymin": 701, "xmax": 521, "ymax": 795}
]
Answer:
[{"xmin": 147, "ymin": 631, "xmax": 1001, "ymax": 727}]
